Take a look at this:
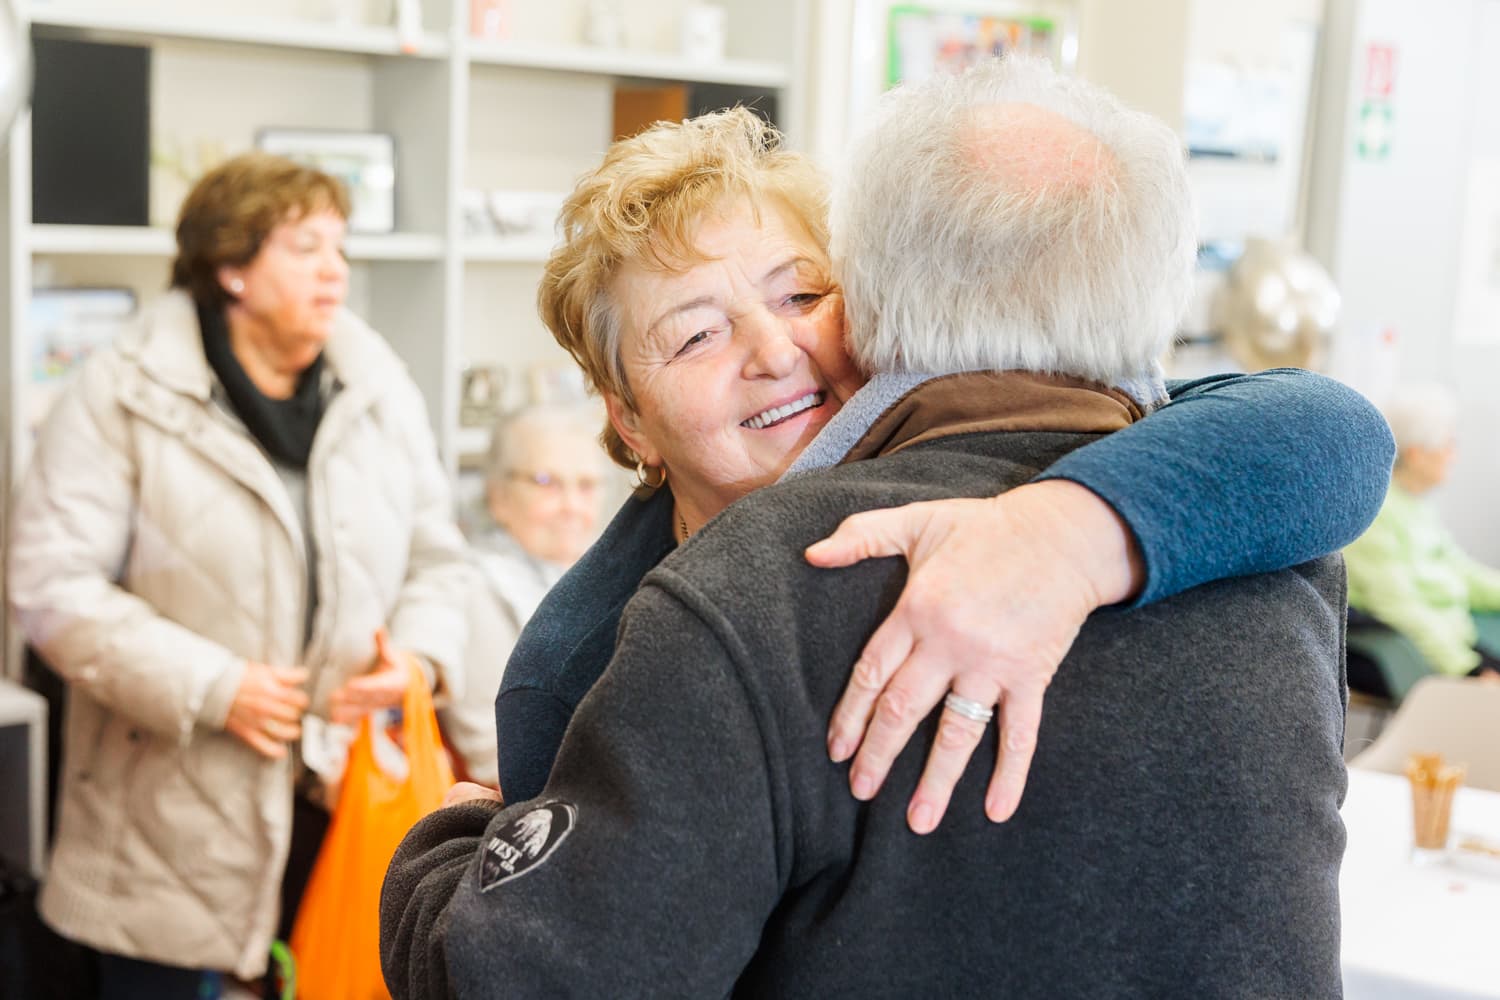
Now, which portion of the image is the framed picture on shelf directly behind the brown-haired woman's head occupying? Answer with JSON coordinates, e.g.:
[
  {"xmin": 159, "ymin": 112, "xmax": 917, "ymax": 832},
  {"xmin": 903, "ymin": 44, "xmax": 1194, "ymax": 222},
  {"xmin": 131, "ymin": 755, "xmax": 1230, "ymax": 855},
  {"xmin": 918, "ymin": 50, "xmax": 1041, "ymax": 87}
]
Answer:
[{"xmin": 255, "ymin": 129, "xmax": 396, "ymax": 232}]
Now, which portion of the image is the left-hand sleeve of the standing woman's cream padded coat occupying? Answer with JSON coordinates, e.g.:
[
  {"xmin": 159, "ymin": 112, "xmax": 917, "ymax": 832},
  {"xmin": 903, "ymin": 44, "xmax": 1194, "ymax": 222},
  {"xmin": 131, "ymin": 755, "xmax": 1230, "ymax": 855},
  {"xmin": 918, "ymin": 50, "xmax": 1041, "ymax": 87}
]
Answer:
[{"xmin": 8, "ymin": 352, "xmax": 245, "ymax": 741}]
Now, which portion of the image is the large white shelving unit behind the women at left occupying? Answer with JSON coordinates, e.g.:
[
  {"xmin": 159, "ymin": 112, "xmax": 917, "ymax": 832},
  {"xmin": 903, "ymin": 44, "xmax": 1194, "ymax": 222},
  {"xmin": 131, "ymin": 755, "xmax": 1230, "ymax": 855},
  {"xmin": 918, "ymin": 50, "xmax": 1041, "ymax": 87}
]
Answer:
[{"xmin": 0, "ymin": 0, "xmax": 812, "ymax": 673}]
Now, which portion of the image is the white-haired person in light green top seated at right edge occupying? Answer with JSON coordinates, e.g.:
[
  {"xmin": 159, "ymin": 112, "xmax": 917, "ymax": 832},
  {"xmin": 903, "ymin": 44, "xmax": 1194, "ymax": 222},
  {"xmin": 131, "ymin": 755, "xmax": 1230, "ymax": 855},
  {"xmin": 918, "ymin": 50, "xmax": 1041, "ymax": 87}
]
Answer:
[{"xmin": 1344, "ymin": 384, "xmax": 1500, "ymax": 694}]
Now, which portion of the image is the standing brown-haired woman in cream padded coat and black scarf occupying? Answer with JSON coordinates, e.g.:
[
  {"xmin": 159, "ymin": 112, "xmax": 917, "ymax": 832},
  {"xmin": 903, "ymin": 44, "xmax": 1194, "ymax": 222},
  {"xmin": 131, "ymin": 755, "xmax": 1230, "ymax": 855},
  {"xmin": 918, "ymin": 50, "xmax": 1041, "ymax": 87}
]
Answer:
[{"xmin": 9, "ymin": 154, "xmax": 471, "ymax": 997}]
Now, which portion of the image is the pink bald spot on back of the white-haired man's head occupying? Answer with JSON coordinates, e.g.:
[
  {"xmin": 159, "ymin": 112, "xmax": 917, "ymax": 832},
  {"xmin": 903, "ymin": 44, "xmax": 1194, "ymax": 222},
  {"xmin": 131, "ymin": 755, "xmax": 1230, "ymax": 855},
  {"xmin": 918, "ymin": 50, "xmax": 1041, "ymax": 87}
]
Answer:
[{"xmin": 959, "ymin": 103, "xmax": 1116, "ymax": 195}]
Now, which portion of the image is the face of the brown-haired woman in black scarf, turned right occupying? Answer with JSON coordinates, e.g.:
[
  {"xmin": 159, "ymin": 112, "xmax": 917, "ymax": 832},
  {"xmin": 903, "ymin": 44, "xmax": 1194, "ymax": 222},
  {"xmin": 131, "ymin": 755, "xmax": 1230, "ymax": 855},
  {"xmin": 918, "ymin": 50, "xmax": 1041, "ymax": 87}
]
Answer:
[{"xmin": 221, "ymin": 210, "xmax": 350, "ymax": 369}]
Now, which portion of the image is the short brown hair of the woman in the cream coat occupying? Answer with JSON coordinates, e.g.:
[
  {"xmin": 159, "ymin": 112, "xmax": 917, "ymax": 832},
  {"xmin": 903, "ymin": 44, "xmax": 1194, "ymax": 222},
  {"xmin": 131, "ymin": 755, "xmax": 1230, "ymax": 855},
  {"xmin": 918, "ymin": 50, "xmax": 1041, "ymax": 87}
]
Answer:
[{"xmin": 173, "ymin": 153, "xmax": 350, "ymax": 306}]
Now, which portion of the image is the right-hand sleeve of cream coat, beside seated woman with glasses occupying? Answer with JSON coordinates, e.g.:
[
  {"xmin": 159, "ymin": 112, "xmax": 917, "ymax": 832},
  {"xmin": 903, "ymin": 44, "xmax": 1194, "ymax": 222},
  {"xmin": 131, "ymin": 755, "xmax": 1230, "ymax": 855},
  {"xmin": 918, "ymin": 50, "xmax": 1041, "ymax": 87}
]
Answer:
[{"xmin": 389, "ymin": 375, "xmax": 480, "ymax": 696}]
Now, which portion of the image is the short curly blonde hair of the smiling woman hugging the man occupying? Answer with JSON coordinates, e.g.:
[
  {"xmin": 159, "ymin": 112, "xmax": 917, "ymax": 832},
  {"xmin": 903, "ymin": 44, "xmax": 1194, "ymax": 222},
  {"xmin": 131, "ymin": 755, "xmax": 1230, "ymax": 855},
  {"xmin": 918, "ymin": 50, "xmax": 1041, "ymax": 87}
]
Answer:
[{"xmin": 537, "ymin": 108, "xmax": 828, "ymax": 469}]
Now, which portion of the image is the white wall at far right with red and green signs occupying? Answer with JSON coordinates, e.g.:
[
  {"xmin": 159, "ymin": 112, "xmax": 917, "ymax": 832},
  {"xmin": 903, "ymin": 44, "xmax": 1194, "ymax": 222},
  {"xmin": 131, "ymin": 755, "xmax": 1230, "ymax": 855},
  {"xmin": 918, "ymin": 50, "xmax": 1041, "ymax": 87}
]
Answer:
[{"xmin": 1310, "ymin": 0, "xmax": 1500, "ymax": 565}]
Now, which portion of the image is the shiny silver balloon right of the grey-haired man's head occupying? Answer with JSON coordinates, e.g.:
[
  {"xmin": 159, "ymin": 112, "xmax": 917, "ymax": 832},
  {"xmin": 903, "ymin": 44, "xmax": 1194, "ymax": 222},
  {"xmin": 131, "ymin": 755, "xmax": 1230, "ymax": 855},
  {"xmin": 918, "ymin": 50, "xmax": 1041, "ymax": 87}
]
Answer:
[{"xmin": 1214, "ymin": 238, "xmax": 1341, "ymax": 372}]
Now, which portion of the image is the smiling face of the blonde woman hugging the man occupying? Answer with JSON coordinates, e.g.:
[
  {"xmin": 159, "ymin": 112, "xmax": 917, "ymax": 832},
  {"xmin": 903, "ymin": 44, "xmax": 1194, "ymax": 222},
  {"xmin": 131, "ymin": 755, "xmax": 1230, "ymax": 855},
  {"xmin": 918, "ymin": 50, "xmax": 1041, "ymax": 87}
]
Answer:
[{"xmin": 606, "ymin": 201, "xmax": 860, "ymax": 519}]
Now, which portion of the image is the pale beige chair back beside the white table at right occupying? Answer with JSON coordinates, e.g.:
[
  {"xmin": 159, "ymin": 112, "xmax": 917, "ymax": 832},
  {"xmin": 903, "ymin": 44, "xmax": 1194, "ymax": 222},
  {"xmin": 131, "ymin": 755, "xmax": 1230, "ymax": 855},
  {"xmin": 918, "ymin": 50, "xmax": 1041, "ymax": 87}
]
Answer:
[{"xmin": 1349, "ymin": 676, "xmax": 1500, "ymax": 792}]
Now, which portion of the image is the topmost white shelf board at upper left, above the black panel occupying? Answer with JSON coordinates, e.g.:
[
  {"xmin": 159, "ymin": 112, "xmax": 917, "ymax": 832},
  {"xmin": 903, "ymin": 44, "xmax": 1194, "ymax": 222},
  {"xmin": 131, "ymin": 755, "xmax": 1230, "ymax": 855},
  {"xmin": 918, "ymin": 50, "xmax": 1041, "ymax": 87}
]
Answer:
[{"xmin": 29, "ymin": 4, "xmax": 449, "ymax": 58}]
